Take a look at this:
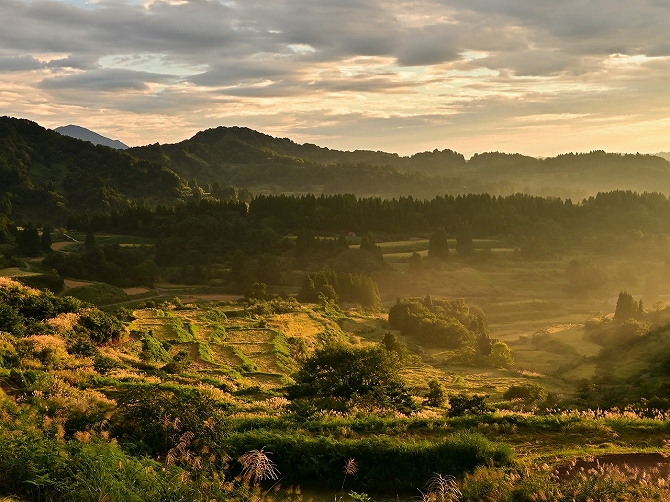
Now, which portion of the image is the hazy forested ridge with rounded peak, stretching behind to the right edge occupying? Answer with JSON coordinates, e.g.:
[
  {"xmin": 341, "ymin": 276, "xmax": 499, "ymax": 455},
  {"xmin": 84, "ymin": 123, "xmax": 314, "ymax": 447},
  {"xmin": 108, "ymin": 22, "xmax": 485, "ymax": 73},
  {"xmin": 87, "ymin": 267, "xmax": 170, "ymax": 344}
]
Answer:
[{"xmin": 130, "ymin": 127, "xmax": 670, "ymax": 198}]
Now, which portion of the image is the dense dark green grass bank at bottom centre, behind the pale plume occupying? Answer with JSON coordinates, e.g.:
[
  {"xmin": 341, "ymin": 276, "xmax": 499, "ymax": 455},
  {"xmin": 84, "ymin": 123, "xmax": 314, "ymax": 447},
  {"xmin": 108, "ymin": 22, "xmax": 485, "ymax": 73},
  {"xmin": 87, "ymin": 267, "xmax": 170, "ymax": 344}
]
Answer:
[{"xmin": 221, "ymin": 431, "xmax": 512, "ymax": 492}]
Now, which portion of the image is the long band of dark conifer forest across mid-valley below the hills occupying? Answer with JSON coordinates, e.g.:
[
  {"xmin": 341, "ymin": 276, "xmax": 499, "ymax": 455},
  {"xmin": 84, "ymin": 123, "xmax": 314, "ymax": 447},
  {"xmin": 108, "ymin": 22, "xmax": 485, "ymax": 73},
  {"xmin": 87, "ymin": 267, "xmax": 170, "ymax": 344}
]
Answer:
[{"xmin": 59, "ymin": 192, "xmax": 670, "ymax": 271}]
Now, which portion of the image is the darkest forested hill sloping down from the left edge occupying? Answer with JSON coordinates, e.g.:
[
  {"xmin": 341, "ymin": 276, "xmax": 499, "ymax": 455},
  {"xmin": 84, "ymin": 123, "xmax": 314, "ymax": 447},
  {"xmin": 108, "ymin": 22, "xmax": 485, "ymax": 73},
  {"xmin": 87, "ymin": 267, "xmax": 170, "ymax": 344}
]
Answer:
[{"xmin": 0, "ymin": 117, "xmax": 185, "ymax": 223}]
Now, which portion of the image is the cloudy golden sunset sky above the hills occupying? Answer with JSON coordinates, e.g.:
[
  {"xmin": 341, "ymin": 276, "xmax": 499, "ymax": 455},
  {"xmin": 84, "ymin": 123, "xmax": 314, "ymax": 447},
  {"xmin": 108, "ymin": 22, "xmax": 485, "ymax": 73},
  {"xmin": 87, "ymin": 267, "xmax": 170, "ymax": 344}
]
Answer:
[{"xmin": 0, "ymin": 0, "xmax": 670, "ymax": 157}]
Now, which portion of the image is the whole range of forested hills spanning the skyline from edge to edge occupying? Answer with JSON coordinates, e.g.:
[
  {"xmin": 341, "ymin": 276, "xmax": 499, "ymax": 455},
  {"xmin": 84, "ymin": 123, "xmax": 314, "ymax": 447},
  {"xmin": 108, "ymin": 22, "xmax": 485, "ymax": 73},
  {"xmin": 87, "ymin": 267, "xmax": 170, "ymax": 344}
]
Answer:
[{"xmin": 0, "ymin": 117, "xmax": 670, "ymax": 224}]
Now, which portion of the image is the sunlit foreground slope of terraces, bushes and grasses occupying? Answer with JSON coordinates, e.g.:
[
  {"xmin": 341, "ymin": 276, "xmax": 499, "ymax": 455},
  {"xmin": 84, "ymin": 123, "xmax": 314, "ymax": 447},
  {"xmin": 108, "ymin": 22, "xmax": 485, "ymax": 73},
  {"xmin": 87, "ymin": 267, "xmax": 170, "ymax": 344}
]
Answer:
[{"xmin": 0, "ymin": 280, "xmax": 670, "ymax": 501}]
